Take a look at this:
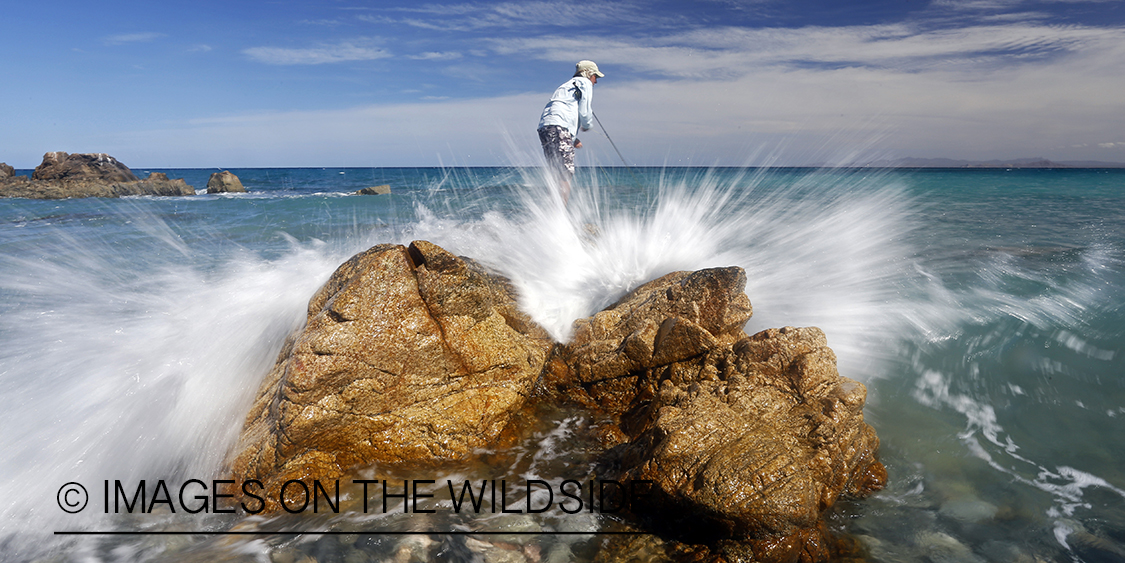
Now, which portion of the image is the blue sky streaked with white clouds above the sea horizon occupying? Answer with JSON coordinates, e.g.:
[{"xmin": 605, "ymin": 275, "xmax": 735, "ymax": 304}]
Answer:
[{"xmin": 0, "ymin": 0, "xmax": 1125, "ymax": 168}]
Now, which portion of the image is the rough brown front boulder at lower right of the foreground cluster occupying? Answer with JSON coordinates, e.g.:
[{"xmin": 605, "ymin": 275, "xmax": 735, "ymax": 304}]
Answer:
[{"xmin": 614, "ymin": 328, "xmax": 887, "ymax": 561}]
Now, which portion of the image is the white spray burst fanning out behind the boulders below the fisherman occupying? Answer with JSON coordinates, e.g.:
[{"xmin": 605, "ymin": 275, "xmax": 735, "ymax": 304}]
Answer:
[{"xmin": 407, "ymin": 164, "xmax": 914, "ymax": 379}]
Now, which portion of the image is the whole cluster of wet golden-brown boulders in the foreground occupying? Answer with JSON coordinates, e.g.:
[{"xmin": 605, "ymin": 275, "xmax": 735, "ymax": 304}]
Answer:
[{"xmin": 232, "ymin": 241, "xmax": 887, "ymax": 561}]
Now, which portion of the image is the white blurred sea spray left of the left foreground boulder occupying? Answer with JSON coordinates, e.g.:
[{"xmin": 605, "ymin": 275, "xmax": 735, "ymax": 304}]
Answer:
[{"xmin": 0, "ymin": 204, "xmax": 344, "ymax": 561}]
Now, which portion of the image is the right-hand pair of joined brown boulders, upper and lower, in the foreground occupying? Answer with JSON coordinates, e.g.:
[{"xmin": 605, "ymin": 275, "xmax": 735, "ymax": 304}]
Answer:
[{"xmin": 549, "ymin": 268, "xmax": 885, "ymax": 561}]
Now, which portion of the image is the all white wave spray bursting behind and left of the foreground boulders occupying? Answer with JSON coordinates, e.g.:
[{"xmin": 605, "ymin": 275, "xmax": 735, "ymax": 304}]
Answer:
[{"xmin": 0, "ymin": 165, "xmax": 922, "ymax": 558}]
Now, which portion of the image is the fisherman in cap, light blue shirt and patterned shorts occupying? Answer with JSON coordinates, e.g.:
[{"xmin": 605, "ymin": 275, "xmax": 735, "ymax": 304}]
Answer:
[{"xmin": 539, "ymin": 61, "xmax": 605, "ymax": 206}]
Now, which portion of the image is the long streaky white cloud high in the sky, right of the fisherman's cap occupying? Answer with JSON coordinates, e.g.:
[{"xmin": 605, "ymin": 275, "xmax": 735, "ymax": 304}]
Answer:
[{"xmin": 493, "ymin": 24, "xmax": 1125, "ymax": 78}]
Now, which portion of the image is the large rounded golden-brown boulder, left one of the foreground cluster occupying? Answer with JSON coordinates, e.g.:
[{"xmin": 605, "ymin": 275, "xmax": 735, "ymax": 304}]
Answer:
[{"xmin": 233, "ymin": 241, "xmax": 551, "ymax": 504}]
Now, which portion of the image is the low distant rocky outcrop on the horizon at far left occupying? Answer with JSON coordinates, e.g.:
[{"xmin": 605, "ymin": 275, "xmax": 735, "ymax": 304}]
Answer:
[{"xmin": 0, "ymin": 152, "xmax": 196, "ymax": 199}]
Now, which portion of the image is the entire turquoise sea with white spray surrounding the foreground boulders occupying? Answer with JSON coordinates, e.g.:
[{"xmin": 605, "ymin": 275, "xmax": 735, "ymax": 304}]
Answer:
[{"xmin": 0, "ymin": 168, "xmax": 1125, "ymax": 561}]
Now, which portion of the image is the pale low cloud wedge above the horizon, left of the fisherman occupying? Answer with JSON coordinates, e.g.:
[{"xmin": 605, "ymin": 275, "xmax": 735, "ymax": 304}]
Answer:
[{"xmin": 118, "ymin": 95, "xmax": 541, "ymax": 167}]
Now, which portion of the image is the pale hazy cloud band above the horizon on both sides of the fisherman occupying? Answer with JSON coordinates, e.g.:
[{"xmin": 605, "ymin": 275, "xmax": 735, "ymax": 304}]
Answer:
[{"xmin": 109, "ymin": 46, "xmax": 1125, "ymax": 166}]
